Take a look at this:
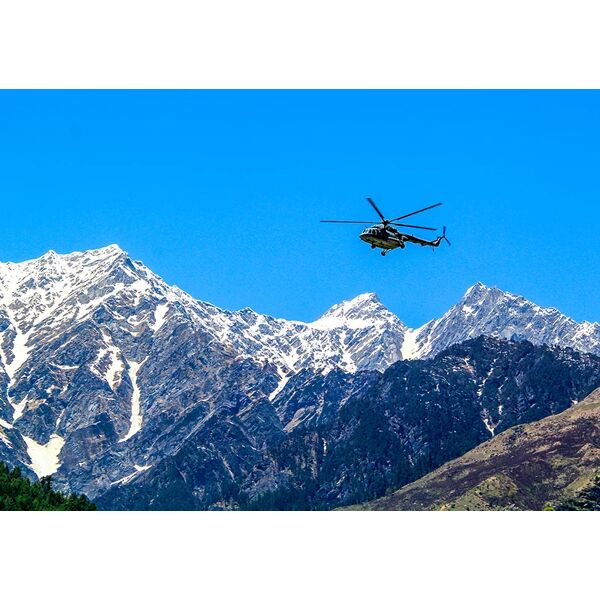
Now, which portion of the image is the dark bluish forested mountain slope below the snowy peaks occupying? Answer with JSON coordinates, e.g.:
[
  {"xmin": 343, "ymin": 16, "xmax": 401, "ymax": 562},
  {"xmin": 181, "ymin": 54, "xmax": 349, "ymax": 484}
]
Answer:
[{"xmin": 96, "ymin": 338, "xmax": 600, "ymax": 510}]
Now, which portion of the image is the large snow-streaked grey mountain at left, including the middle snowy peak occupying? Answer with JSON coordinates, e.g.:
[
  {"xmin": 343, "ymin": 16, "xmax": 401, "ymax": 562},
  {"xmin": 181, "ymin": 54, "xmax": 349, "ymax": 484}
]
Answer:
[{"xmin": 0, "ymin": 241, "xmax": 405, "ymax": 494}]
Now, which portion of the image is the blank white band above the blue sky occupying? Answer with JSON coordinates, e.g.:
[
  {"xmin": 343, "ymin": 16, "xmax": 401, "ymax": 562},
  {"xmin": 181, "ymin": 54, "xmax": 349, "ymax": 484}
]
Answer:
[{"xmin": 0, "ymin": 0, "xmax": 599, "ymax": 88}]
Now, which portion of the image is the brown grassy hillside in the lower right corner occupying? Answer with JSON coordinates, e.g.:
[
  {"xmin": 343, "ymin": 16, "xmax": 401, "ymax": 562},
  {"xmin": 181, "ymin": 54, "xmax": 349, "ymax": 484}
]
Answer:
[{"xmin": 357, "ymin": 389, "xmax": 600, "ymax": 510}]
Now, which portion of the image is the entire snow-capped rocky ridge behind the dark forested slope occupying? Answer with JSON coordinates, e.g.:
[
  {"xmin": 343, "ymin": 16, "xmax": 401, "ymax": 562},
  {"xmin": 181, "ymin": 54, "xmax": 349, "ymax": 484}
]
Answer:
[{"xmin": 0, "ymin": 245, "xmax": 600, "ymax": 506}]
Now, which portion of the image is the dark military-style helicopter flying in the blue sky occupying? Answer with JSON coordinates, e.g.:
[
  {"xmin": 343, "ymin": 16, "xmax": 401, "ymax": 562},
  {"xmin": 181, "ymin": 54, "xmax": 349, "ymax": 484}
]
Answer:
[{"xmin": 321, "ymin": 198, "xmax": 452, "ymax": 256}]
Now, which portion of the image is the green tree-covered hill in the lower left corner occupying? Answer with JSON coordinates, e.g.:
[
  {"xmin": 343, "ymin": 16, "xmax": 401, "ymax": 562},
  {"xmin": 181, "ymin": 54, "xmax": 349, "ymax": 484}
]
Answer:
[{"xmin": 0, "ymin": 463, "xmax": 96, "ymax": 510}]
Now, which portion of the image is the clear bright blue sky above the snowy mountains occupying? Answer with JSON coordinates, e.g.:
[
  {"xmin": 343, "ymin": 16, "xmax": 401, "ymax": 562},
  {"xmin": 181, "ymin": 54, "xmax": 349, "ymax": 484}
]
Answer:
[{"xmin": 0, "ymin": 91, "xmax": 600, "ymax": 326}]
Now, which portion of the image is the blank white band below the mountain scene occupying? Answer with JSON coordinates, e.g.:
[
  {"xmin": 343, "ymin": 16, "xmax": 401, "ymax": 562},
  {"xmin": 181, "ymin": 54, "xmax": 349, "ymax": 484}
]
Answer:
[{"xmin": 0, "ymin": 512, "xmax": 598, "ymax": 600}]
